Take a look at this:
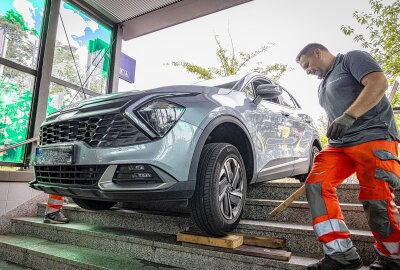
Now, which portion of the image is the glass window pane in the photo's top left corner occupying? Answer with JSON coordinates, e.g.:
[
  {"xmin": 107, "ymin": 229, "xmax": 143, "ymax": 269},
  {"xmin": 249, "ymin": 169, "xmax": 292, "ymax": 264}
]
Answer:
[{"xmin": 0, "ymin": 0, "xmax": 45, "ymax": 69}]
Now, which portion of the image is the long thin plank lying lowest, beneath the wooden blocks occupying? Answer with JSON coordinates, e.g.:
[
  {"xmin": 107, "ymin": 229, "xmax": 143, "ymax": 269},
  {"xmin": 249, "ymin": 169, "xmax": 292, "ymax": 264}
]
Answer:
[{"xmin": 182, "ymin": 243, "xmax": 292, "ymax": 261}]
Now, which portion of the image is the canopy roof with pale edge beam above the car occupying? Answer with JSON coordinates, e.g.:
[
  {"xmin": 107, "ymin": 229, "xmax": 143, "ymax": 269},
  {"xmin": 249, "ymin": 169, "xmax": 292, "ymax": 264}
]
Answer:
[{"xmin": 80, "ymin": 0, "xmax": 252, "ymax": 40}]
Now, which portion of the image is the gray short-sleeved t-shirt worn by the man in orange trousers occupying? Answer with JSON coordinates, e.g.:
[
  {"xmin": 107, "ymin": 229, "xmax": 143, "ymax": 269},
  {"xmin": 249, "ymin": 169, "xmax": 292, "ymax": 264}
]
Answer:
[{"xmin": 318, "ymin": 51, "xmax": 399, "ymax": 147}]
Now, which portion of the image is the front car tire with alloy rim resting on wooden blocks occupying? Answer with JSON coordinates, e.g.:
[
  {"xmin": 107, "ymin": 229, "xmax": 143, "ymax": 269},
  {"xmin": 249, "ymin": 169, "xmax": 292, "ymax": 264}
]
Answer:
[{"xmin": 190, "ymin": 143, "xmax": 247, "ymax": 236}]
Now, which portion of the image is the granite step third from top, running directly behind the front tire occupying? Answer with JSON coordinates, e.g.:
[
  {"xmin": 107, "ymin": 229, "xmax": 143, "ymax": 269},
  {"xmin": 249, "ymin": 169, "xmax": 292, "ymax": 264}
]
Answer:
[{"xmin": 39, "ymin": 204, "xmax": 375, "ymax": 263}]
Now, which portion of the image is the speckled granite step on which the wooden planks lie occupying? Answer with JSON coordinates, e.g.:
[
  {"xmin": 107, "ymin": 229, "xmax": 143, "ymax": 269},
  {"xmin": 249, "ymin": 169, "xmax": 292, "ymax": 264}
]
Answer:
[{"xmin": 13, "ymin": 218, "xmax": 367, "ymax": 270}]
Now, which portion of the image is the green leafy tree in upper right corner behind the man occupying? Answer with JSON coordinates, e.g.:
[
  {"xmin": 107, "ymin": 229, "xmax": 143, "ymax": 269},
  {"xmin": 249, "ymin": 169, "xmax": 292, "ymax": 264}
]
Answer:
[{"xmin": 341, "ymin": 0, "xmax": 400, "ymax": 83}]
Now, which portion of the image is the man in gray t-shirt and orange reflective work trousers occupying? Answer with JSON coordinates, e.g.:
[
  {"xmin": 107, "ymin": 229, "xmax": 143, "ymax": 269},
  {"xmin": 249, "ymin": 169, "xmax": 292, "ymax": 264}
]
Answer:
[{"xmin": 296, "ymin": 43, "xmax": 400, "ymax": 270}]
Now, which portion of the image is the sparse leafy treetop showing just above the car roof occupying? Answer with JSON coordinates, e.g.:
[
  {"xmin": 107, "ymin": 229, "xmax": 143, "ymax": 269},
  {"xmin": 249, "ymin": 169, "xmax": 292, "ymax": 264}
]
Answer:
[{"xmin": 167, "ymin": 35, "xmax": 291, "ymax": 81}]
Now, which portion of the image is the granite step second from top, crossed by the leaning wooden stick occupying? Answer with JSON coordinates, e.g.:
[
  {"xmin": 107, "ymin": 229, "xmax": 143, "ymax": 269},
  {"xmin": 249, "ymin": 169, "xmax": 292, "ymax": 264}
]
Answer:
[{"xmin": 243, "ymin": 199, "xmax": 388, "ymax": 230}]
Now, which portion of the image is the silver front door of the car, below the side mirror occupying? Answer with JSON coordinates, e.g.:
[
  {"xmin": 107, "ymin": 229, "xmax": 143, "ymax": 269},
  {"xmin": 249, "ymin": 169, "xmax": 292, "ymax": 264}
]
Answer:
[{"xmin": 244, "ymin": 78, "xmax": 293, "ymax": 181}]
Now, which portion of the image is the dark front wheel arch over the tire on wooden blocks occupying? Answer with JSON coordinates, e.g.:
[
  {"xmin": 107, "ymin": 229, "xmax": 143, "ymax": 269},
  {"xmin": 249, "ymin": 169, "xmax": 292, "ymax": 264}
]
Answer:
[{"xmin": 189, "ymin": 115, "xmax": 257, "ymax": 185}]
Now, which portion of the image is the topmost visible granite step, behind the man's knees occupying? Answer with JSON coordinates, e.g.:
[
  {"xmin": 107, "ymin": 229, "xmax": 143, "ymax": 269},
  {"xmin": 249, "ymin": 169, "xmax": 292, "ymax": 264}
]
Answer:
[{"xmin": 247, "ymin": 182, "xmax": 400, "ymax": 206}]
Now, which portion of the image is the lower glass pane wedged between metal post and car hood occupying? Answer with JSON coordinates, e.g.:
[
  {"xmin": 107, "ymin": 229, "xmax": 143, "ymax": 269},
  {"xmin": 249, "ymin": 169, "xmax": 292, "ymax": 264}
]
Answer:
[{"xmin": 47, "ymin": 83, "xmax": 91, "ymax": 115}]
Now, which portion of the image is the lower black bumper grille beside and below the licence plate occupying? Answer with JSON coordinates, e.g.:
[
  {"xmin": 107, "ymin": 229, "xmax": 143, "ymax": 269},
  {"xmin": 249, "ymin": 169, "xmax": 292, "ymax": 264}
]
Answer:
[{"xmin": 35, "ymin": 165, "xmax": 107, "ymax": 186}]
